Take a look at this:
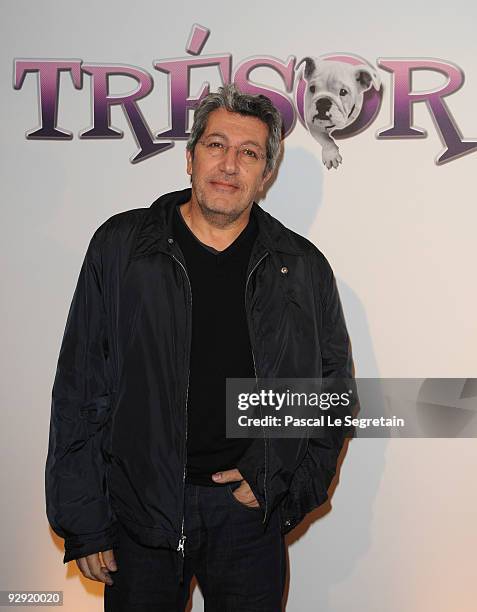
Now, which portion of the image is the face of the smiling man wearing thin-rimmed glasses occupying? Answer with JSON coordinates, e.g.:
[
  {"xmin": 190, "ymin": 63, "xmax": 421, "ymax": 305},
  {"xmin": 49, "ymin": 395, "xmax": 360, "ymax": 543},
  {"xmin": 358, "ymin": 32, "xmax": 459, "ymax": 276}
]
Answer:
[{"xmin": 186, "ymin": 108, "xmax": 271, "ymax": 226}]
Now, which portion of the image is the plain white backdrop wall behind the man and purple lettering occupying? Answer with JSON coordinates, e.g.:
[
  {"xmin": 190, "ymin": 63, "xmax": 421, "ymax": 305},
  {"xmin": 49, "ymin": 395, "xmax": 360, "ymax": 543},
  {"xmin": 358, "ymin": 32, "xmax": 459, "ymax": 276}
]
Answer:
[{"xmin": 0, "ymin": 0, "xmax": 477, "ymax": 612}]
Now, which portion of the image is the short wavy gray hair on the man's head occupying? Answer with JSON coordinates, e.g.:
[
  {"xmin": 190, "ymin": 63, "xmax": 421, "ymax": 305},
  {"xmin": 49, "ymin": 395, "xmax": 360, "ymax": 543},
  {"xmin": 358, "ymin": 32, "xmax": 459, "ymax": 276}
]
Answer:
[{"xmin": 186, "ymin": 83, "xmax": 283, "ymax": 175}]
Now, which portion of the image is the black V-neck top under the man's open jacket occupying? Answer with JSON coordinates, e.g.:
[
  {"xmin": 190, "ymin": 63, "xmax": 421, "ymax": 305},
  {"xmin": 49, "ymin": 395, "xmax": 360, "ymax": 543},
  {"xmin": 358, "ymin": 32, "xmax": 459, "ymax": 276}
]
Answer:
[{"xmin": 174, "ymin": 207, "xmax": 258, "ymax": 486}]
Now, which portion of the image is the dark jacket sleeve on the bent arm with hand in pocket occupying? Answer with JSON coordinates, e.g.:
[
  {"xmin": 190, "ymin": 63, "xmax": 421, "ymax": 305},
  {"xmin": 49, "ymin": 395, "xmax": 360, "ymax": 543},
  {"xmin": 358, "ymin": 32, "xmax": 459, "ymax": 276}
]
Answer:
[{"xmin": 280, "ymin": 253, "xmax": 358, "ymax": 516}]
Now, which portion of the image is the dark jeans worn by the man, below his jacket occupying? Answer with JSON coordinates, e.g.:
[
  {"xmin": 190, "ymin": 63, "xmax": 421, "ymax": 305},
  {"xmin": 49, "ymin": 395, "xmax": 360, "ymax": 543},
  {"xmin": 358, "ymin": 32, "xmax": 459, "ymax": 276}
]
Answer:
[{"xmin": 104, "ymin": 483, "xmax": 286, "ymax": 612}]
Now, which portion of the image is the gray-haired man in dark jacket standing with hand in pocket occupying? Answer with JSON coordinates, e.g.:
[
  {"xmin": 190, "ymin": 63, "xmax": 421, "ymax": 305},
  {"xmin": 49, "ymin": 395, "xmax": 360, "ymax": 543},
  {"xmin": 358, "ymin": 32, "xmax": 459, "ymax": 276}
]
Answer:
[{"xmin": 46, "ymin": 85, "xmax": 352, "ymax": 612}]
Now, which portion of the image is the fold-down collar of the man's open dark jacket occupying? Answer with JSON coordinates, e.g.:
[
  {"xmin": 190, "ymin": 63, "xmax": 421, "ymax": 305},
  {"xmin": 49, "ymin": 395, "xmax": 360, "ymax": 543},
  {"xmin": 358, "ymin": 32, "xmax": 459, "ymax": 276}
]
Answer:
[{"xmin": 131, "ymin": 187, "xmax": 304, "ymax": 259}]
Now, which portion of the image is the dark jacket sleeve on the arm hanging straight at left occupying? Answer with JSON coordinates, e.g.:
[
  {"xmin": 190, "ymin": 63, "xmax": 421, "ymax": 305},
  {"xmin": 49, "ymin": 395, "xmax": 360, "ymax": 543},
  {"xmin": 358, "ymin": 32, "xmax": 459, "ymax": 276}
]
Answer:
[{"xmin": 45, "ymin": 230, "xmax": 116, "ymax": 563}]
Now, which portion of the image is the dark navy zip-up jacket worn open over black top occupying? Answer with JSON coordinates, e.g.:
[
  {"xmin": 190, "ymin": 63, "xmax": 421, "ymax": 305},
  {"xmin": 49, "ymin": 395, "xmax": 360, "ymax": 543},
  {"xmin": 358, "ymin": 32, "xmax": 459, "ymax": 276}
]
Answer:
[{"xmin": 46, "ymin": 189, "xmax": 353, "ymax": 563}]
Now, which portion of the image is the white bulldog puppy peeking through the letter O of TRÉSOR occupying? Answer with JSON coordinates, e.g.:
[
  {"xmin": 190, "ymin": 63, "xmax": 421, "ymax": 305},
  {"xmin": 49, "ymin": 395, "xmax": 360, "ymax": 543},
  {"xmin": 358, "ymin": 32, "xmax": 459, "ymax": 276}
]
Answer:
[{"xmin": 297, "ymin": 57, "xmax": 381, "ymax": 169}]
